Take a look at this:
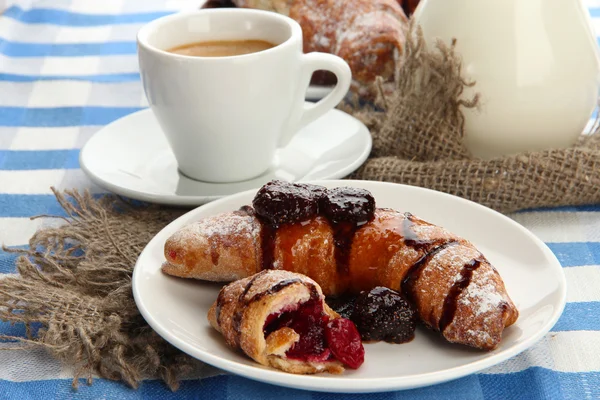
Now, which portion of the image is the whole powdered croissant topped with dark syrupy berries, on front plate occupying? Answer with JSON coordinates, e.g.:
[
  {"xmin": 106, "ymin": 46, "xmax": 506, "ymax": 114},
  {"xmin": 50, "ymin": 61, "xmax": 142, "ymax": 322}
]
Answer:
[{"xmin": 163, "ymin": 181, "xmax": 519, "ymax": 350}]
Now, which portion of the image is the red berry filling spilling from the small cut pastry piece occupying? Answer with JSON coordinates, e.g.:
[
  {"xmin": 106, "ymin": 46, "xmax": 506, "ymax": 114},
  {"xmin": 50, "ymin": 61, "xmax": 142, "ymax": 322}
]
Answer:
[{"xmin": 263, "ymin": 299, "xmax": 365, "ymax": 368}]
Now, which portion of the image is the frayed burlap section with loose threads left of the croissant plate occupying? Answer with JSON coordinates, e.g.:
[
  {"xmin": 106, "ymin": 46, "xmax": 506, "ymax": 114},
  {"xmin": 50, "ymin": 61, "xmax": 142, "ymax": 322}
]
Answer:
[{"xmin": 0, "ymin": 189, "xmax": 198, "ymax": 390}]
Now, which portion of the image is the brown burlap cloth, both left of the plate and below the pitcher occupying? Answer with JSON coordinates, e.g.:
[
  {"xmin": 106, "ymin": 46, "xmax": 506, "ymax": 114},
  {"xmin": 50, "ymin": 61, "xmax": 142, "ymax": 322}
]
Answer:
[{"xmin": 0, "ymin": 26, "xmax": 600, "ymax": 389}]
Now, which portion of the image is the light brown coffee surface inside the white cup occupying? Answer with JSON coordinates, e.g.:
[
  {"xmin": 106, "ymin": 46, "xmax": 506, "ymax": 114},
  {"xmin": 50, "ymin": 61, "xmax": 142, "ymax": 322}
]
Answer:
[{"xmin": 167, "ymin": 40, "xmax": 275, "ymax": 57}]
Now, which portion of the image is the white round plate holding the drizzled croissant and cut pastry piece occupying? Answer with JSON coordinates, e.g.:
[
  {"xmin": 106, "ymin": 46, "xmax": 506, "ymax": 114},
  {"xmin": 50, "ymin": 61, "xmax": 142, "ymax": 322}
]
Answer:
[{"xmin": 133, "ymin": 181, "xmax": 566, "ymax": 392}]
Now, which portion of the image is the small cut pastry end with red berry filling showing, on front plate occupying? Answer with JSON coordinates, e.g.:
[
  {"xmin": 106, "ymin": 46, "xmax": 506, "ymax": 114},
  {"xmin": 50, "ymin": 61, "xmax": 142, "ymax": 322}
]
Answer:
[{"xmin": 208, "ymin": 270, "xmax": 365, "ymax": 374}]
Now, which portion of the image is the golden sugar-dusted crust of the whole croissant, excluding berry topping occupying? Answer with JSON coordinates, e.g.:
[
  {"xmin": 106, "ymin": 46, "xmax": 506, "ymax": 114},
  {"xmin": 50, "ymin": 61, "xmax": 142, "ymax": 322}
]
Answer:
[{"xmin": 163, "ymin": 209, "xmax": 519, "ymax": 350}]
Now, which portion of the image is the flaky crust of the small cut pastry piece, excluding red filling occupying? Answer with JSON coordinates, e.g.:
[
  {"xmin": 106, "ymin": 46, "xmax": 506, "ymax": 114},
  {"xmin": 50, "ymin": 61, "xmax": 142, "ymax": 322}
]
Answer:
[{"xmin": 208, "ymin": 270, "xmax": 344, "ymax": 374}]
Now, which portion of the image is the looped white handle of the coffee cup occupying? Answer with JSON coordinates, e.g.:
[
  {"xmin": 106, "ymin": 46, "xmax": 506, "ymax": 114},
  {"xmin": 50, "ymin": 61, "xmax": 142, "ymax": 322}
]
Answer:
[{"xmin": 279, "ymin": 52, "xmax": 352, "ymax": 147}]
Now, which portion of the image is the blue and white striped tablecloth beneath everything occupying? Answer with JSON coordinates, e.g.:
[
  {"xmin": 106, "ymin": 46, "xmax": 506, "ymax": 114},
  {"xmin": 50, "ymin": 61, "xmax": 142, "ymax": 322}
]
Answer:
[{"xmin": 0, "ymin": 0, "xmax": 600, "ymax": 400}]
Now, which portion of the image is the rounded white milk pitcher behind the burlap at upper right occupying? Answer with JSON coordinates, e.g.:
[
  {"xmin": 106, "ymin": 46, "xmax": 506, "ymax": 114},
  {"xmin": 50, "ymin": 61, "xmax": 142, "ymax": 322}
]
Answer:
[{"xmin": 414, "ymin": 0, "xmax": 600, "ymax": 158}]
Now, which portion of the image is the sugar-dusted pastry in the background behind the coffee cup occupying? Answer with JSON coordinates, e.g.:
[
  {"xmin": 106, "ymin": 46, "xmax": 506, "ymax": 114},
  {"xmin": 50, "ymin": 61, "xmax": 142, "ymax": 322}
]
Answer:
[{"xmin": 232, "ymin": 0, "xmax": 408, "ymax": 96}]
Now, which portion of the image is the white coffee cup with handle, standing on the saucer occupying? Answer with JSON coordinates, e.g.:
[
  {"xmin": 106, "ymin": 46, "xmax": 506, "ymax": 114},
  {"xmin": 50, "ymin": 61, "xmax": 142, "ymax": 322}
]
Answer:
[{"xmin": 137, "ymin": 9, "xmax": 351, "ymax": 182}]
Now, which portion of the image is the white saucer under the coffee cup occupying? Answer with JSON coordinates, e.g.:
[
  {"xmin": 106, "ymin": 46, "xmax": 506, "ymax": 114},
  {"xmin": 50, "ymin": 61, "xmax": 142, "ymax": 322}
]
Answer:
[{"xmin": 79, "ymin": 109, "xmax": 371, "ymax": 206}]
